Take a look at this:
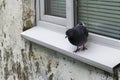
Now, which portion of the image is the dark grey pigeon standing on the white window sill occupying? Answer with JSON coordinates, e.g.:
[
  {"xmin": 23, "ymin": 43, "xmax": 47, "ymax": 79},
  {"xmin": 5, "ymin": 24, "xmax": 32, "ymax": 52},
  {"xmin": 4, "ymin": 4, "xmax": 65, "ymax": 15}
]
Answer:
[{"xmin": 65, "ymin": 23, "xmax": 88, "ymax": 53}]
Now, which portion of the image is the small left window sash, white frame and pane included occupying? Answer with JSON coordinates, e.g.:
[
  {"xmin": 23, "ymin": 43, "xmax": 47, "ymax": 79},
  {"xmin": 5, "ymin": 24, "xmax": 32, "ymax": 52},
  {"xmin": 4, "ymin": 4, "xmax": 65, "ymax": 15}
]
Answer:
[{"xmin": 40, "ymin": 0, "xmax": 74, "ymax": 28}]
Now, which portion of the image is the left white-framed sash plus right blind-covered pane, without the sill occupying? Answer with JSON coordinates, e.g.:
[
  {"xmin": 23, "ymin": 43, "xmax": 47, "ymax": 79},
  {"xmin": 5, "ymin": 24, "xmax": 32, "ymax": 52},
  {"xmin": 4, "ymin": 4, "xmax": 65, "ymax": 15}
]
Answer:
[{"xmin": 40, "ymin": 0, "xmax": 120, "ymax": 39}]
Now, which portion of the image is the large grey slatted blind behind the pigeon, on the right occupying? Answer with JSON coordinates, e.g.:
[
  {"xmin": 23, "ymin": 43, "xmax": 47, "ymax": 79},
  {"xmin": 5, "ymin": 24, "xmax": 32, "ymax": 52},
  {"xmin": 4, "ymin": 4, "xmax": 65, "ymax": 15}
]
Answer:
[{"xmin": 77, "ymin": 0, "xmax": 120, "ymax": 39}]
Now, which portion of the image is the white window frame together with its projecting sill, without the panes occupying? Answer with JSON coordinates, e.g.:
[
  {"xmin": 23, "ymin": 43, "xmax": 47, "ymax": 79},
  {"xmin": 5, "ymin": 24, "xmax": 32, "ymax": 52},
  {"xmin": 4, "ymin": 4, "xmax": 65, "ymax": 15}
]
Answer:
[{"xmin": 21, "ymin": 0, "xmax": 120, "ymax": 73}]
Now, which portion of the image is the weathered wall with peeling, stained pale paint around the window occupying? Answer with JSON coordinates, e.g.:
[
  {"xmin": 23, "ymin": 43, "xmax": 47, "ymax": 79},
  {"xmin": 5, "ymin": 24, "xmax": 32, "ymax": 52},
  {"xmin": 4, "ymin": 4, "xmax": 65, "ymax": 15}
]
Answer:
[{"xmin": 0, "ymin": 0, "xmax": 119, "ymax": 80}]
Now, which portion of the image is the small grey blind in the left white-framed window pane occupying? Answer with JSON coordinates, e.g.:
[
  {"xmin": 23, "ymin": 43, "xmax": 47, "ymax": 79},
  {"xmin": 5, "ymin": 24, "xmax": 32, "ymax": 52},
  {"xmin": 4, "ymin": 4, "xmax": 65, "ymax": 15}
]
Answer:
[{"xmin": 45, "ymin": 0, "xmax": 66, "ymax": 18}]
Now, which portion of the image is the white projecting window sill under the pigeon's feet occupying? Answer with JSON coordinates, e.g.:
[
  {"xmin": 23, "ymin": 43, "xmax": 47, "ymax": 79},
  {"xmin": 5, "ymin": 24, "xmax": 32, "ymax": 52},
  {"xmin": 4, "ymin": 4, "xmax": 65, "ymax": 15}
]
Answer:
[{"xmin": 21, "ymin": 21, "xmax": 120, "ymax": 73}]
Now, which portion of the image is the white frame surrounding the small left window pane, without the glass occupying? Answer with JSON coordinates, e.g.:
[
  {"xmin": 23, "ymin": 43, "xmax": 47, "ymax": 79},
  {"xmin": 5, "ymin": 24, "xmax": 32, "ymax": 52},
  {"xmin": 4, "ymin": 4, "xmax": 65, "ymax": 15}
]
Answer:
[{"xmin": 38, "ymin": 0, "xmax": 74, "ymax": 29}]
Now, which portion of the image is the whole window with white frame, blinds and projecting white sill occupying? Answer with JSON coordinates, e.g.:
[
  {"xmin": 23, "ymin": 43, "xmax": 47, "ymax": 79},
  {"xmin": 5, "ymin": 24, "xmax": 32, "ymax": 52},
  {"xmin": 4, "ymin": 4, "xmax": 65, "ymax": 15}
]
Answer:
[{"xmin": 21, "ymin": 0, "xmax": 120, "ymax": 73}]
